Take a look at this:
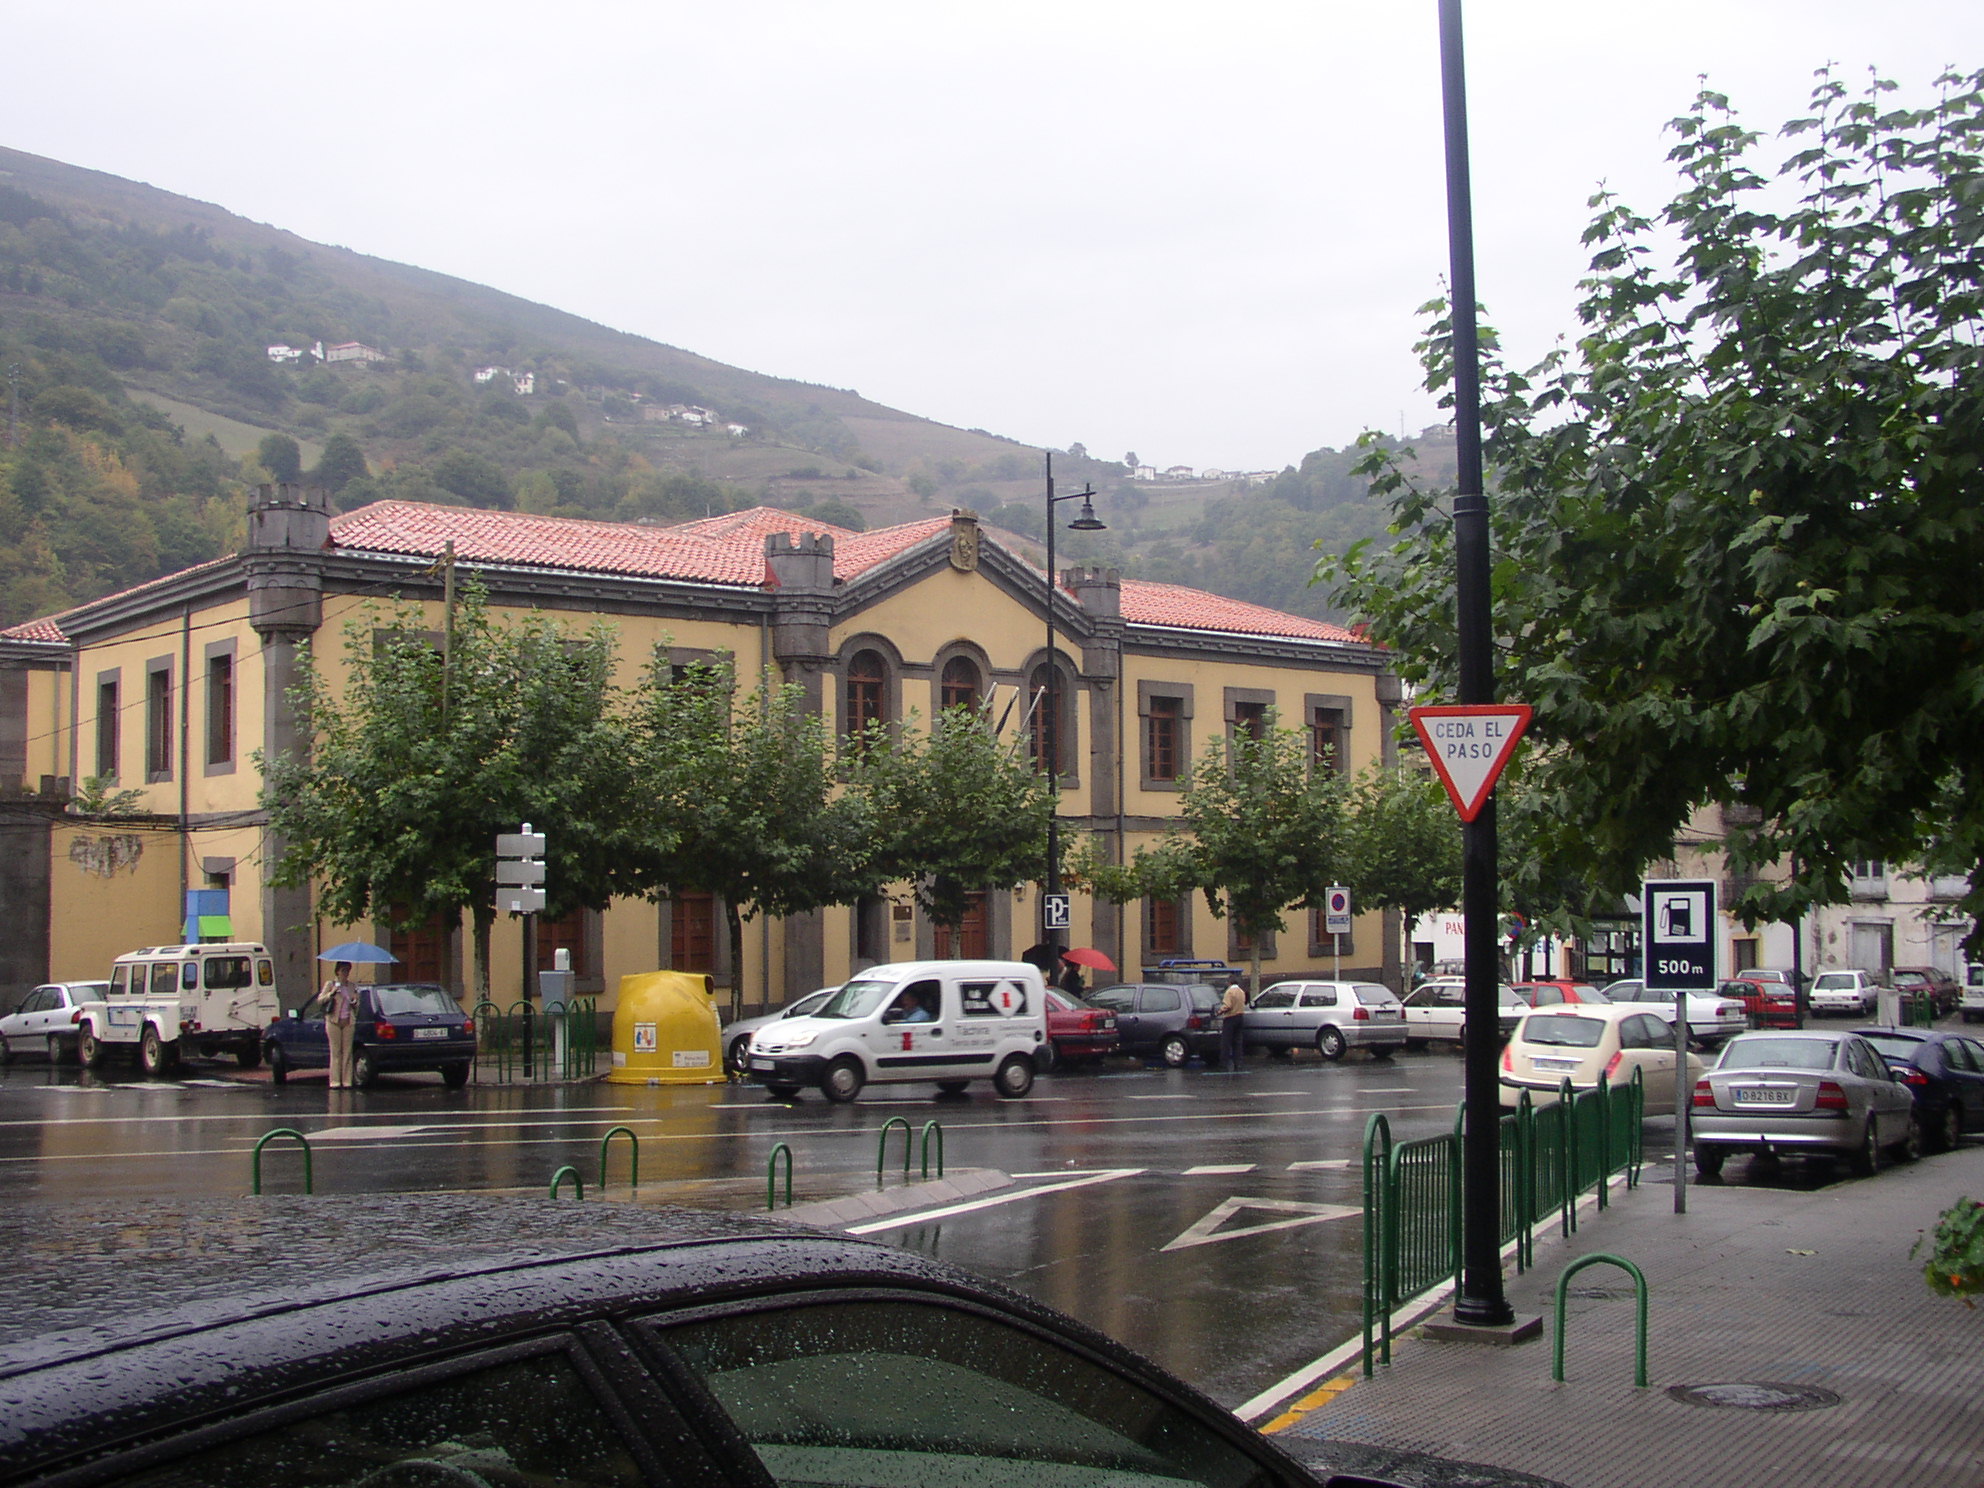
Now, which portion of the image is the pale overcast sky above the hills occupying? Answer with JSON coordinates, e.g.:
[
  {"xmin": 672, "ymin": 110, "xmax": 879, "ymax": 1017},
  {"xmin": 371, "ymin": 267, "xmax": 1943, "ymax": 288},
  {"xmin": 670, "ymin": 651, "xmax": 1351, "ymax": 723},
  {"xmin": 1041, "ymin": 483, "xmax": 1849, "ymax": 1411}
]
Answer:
[{"xmin": 0, "ymin": 0, "xmax": 1984, "ymax": 468}]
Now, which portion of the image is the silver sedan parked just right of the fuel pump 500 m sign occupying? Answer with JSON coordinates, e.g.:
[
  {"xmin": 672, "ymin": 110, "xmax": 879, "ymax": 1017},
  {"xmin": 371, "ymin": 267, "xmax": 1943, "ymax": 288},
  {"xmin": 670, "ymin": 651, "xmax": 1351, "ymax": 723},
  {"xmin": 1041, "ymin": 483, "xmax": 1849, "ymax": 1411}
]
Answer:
[{"xmin": 1690, "ymin": 1028, "xmax": 1922, "ymax": 1177}]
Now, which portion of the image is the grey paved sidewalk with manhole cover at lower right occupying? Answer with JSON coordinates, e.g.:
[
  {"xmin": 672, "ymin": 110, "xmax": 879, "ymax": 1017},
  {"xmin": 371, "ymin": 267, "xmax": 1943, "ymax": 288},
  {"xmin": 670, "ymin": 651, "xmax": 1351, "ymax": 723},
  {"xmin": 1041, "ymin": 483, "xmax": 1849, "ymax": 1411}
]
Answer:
[{"xmin": 1278, "ymin": 1145, "xmax": 1984, "ymax": 1488}]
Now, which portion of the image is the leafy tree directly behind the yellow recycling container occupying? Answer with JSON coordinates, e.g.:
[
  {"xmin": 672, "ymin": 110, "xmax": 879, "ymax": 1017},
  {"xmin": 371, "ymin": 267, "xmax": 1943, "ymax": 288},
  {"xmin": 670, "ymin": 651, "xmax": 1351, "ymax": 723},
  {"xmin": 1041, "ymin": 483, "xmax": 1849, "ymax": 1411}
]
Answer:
[{"xmin": 629, "ymin": 655, "xmax": 867, "ymax": 1018}]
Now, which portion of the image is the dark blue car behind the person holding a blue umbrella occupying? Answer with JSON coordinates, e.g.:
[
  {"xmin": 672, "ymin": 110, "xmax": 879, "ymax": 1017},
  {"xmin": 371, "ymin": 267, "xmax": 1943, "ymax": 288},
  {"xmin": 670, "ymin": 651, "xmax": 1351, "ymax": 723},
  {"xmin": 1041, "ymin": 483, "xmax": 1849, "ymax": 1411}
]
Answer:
[{"xmin": 262, "ymin": 982, "xmax": 476, "ymax": 1089}]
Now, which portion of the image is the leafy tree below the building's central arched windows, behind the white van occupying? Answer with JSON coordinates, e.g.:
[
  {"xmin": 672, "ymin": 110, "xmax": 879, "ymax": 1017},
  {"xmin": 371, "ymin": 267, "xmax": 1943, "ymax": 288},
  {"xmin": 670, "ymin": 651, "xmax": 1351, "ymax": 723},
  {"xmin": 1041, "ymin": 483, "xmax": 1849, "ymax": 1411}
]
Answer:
[{"xmin": 851, "ymin": 708, "xmax": 1054, "ymax": 929}]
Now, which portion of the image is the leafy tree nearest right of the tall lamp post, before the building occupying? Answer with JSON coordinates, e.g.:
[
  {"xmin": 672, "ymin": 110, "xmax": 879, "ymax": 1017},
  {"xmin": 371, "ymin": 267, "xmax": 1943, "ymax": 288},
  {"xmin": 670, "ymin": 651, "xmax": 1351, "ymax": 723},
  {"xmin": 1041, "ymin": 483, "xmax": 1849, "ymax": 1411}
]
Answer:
[{"xmin": 1077, "ymin": 712, "xmax": 1349, "ymax": 984}]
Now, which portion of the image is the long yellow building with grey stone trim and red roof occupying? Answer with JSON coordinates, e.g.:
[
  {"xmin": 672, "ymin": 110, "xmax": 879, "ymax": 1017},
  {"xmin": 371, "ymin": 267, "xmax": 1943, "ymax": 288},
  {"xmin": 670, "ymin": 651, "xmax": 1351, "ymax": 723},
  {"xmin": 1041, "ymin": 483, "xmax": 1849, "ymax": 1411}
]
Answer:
[{"xmin": 0, "ymin": 486, "xmax": 1399, "ymax": 1006}]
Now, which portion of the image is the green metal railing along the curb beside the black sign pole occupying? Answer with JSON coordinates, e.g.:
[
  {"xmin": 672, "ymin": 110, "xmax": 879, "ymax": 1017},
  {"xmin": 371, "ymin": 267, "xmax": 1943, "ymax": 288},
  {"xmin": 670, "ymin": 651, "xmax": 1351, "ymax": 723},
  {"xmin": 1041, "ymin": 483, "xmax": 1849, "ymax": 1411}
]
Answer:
[{"xmin": 1363, "ymin": 1069, "xmax": 1647, "ymax": 1375}]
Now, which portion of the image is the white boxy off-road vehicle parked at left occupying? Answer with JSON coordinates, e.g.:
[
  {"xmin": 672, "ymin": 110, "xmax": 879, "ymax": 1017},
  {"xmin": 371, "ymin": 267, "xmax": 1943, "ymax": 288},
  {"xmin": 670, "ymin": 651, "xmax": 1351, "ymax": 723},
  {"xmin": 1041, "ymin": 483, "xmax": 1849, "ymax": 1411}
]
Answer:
[{"xmin": 75, "ymin": 942, "xmax": 280, "ymax": 1075}]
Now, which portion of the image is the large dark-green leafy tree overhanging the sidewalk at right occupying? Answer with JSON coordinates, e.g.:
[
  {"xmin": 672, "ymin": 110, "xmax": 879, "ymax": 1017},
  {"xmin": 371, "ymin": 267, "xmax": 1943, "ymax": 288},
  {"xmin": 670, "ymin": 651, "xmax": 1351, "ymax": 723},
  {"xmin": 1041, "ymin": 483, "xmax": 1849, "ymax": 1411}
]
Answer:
[{"xmin": 1323, "ymin": 73, "xmax": 1984, "ymax": 944}]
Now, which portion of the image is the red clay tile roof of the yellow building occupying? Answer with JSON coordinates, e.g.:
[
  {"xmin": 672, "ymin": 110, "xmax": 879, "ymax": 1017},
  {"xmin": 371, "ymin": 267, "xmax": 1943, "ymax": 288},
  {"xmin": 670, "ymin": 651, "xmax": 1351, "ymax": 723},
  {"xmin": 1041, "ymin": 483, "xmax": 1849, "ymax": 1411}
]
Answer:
[{"xmin": 0, "ymin": 502, "xmax": 1361, "ymax": 643}]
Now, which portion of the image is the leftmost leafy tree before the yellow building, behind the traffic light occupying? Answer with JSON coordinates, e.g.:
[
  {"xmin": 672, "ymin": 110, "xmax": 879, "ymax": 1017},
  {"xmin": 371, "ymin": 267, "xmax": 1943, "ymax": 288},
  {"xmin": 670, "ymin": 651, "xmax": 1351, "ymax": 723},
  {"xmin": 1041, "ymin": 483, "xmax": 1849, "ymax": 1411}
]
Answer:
[{"xmin": 256, "ymin": 583, "xmax": 638, "ymax": 996}]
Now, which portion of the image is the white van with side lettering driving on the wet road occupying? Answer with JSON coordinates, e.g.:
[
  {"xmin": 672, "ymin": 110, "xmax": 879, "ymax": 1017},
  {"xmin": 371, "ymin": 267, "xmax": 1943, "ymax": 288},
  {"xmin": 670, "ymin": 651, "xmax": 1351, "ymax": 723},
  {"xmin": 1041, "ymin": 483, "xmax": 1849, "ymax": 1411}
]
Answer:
[{"xmin": 746, "ymin": 960, "xmax": 1048, "ymax": 1101}]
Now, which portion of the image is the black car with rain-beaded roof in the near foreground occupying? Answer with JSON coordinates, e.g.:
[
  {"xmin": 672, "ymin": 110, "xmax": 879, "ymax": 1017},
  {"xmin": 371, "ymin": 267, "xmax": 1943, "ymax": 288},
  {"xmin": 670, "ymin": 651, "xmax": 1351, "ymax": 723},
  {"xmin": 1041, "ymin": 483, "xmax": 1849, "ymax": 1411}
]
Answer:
[{"xmin": 0, "ymin": 1194, "xmax": 1396, "ymax": 1488}]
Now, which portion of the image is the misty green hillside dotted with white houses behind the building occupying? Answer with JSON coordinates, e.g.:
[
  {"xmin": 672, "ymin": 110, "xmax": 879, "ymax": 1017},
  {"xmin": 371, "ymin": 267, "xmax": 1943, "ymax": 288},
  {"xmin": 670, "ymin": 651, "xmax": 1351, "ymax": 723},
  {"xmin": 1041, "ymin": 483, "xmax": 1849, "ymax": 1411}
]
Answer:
[{"xmin": 0, "ymin": 149, "xmax": 1428, "ymax": 623}]
